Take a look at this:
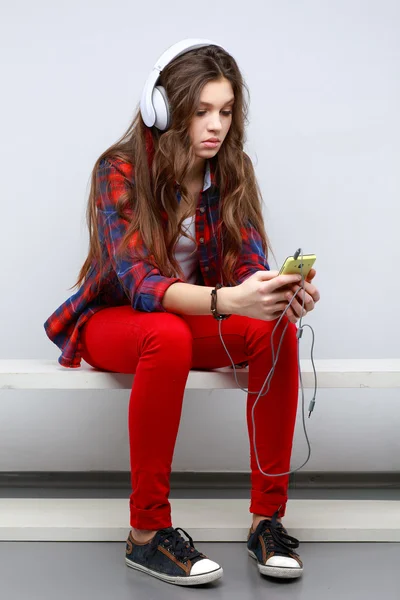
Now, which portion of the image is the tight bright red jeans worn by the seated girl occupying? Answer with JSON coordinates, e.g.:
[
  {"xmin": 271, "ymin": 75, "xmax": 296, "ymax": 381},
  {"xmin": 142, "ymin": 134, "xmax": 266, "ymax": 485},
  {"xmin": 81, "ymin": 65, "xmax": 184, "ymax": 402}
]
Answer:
[{"xmin": 81, "ymin": 305, "xmax": 299, "ymax": 530}]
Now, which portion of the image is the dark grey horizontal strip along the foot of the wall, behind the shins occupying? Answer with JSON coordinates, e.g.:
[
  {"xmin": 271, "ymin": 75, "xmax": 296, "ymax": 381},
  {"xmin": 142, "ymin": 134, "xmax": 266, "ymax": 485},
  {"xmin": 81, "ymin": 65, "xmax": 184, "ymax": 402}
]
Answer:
[{"xmin": 0, "ymin": 471, "xmax": 400, "ymax": 490}]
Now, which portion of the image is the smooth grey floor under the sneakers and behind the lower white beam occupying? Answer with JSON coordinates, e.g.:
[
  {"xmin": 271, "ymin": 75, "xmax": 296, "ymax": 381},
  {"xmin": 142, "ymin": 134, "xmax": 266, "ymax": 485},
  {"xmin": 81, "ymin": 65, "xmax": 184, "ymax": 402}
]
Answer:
[{"xmin": 0, "ymin": 487, "xmax": 400, "ymax": 600}]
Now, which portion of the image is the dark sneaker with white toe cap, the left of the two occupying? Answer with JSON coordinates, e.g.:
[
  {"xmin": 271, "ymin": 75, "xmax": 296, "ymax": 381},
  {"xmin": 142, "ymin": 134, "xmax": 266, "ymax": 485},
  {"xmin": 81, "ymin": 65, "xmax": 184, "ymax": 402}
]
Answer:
[{"xmin": 125, "ymin": 527, "xmax": 223, "ymax": 585}]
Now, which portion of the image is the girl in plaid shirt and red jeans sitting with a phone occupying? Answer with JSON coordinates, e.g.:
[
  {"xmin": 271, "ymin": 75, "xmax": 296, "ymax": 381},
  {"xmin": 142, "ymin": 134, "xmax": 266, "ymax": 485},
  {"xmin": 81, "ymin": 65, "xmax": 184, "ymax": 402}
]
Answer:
[{"xmin": 44, "ymin": 40, "xmax": 319, "ymax": 585}]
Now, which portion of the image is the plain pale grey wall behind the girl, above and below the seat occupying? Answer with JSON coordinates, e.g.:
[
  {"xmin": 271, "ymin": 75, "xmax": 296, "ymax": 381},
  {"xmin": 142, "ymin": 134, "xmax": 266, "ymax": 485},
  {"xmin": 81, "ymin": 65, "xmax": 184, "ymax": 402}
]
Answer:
[{"xmin": 0, "ymin": 0, "xmax": 400, "ymax": 471}]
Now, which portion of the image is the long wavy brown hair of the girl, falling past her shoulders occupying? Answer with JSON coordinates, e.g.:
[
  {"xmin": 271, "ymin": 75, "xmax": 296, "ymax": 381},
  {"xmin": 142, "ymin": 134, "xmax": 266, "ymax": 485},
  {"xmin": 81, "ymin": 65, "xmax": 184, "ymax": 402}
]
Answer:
[{"xmin": 73, "ymin": 45, "xmax": 272, "ymax": 287}]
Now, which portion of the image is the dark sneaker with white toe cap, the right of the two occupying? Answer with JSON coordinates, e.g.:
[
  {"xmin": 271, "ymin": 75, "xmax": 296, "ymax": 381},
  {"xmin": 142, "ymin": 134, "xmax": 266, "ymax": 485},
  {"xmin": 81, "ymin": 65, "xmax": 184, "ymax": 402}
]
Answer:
[{"xmin": 247, "ymin": 511, "xmax": 303, "ymax": 579}]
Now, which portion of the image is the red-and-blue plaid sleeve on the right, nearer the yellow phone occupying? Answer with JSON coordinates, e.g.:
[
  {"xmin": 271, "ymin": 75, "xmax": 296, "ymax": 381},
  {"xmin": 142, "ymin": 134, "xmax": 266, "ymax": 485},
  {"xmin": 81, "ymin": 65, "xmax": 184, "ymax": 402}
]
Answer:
[{"xmin": 234, "ymin": 221, "xmax": 270, "ymax": 285}]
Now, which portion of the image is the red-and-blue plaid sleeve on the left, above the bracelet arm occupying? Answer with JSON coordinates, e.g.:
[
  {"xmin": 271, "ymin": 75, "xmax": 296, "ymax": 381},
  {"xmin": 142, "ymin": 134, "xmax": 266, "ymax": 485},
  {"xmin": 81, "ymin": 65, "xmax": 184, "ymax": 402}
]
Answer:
[{"xmin": 96, "ymin": 159, "xmax": 182, "ymax": 312}]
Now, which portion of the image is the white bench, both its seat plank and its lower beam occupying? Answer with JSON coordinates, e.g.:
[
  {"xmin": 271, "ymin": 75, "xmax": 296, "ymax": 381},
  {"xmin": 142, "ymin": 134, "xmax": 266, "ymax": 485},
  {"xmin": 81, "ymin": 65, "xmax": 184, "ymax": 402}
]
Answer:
[{"xmin": 0, "ymin": 359, "xmax": 400, "ymax": 542}]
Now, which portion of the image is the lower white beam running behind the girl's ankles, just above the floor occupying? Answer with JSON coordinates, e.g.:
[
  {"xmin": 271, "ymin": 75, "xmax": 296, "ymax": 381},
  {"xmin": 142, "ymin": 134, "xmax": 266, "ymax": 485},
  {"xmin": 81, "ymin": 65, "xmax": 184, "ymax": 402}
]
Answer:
[{"xmin": 0, "ymin": 498, "xmax": 400, "ymax": 543}]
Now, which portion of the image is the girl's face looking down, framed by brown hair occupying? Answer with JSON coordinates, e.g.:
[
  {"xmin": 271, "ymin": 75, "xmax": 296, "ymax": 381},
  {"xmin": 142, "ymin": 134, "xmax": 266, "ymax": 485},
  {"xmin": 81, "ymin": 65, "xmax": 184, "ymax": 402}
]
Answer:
[{"xmin": 189, "ymin": 79, "xmax": 234, "ymax": 160}]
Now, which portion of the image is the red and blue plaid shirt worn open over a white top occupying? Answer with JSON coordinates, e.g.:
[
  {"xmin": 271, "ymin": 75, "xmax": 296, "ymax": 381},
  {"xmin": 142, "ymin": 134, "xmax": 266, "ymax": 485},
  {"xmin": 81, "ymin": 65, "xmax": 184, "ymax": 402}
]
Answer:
[{"xmin": 44, "ymin": 158, "xmax": 269, "ymax": 368}]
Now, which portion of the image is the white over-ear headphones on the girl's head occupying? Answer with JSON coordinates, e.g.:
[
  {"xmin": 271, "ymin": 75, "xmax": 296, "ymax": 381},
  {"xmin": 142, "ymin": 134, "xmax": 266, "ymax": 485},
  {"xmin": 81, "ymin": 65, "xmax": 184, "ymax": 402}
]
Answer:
[{"xmin": 140, "ymin": 39, "xmax": 227, "ymax": 131}]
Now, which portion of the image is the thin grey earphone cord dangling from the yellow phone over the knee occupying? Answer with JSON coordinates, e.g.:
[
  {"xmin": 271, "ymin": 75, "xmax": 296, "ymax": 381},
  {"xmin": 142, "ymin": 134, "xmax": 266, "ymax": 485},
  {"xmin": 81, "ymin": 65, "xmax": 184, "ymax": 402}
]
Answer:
[{"xmin": 219, "ymin": 248, "xmax": 317, "ymax": 477}]
